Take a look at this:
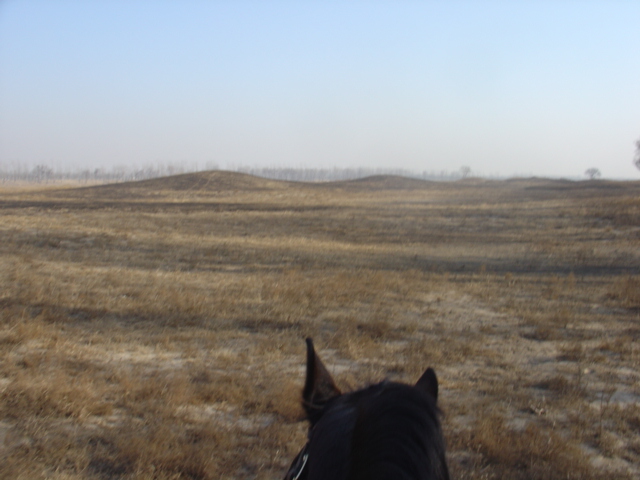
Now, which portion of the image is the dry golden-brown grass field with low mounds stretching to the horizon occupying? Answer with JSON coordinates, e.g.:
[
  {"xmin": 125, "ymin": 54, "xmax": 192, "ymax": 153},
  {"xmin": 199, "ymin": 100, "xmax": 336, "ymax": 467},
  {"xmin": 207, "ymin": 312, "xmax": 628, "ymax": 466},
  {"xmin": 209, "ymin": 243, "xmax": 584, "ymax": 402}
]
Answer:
[{"xmin": 0, "ymin": 172, "xmax": 640, "ymax": 480}]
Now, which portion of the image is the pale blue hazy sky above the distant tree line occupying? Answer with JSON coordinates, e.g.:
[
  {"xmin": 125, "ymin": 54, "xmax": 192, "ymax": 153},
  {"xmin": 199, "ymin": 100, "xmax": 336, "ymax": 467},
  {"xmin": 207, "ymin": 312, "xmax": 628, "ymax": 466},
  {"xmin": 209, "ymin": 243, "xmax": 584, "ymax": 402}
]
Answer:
[{"xmin": 0, "ymin": 0, "xmax": 640, "ymax": 178}]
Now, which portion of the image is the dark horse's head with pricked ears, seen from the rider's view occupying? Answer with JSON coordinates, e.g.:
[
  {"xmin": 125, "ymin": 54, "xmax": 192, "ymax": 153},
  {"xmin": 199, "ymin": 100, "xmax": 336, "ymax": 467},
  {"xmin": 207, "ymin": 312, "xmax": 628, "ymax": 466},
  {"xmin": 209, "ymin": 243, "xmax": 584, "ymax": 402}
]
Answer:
[{"xmin": 285, "ymin": 339, "xmax": 449, "ymax": 480}]
